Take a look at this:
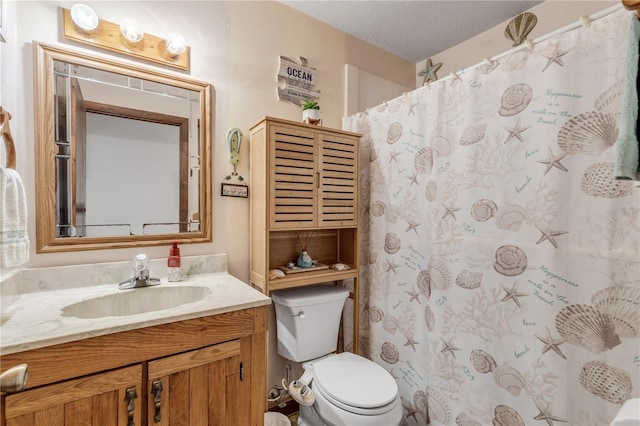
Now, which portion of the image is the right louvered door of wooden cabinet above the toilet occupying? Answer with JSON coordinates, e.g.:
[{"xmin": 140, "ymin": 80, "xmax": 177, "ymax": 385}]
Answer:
[{"xmin": 318, "ymin": 133, "xmax": 359, "ymax": 228}]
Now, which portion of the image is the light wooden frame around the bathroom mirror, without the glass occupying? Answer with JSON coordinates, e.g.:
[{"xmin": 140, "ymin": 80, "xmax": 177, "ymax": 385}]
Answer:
[{"xmin": 34, "ymin": 42, "xmax": 213, "ymax": 253}]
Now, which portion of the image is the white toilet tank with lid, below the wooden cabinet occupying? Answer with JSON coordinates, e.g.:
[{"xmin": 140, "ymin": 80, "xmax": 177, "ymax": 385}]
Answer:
[{"xmin": 271, "ymin": 285, "xmax": 349, "ymax": 362}]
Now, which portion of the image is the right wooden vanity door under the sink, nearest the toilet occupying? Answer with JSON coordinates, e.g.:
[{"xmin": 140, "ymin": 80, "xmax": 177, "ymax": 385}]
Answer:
[{"xmin": 147, "ymin": 340, "xmax": 242, "ymax": 426}]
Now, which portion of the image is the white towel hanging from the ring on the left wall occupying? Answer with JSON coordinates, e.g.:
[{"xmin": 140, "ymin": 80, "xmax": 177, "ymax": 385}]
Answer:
[{"xmin": 0, "ymin": 167, "xmax": 29, "ymax": 271}]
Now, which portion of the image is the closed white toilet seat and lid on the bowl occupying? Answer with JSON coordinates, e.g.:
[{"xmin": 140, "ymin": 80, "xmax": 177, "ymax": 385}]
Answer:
[{"xmin": 312, "ymin": 352, "xmax": 398, "ymax": 416}]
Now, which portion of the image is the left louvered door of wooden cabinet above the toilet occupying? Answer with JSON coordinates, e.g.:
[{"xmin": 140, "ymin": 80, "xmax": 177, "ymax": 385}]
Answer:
[{"xmin": 269, "ymin": 126, "xmax": 319, "ymax": 229}]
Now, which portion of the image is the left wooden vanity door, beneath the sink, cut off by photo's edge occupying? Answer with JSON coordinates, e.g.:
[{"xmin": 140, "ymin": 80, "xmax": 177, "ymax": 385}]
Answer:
[{"xmin": 3, "ymin": 365, "xmax": 142, "ymax": 426}]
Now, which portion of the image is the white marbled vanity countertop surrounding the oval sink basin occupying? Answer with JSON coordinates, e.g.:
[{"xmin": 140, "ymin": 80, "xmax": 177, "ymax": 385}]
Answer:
[{"xmin": 0, "ymin": 272, "xmax": 271, "ymax": 355}]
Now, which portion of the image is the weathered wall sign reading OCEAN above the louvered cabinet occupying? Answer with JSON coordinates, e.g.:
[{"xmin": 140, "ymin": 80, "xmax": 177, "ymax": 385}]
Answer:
[{"xmin": 278, "ymin": 56, "xmax": 320, "ymax": 105}]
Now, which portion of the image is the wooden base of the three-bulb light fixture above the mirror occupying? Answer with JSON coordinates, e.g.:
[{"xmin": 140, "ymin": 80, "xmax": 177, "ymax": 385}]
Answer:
[{"xmin": 62, "ymin": 9, "xmax": 191, "ymax": 71}]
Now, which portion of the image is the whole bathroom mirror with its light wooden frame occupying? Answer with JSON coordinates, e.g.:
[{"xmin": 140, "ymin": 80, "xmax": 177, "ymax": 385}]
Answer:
[{"xmin": 34, "ymin": 42, "xmax": 212, "ymax": 253}]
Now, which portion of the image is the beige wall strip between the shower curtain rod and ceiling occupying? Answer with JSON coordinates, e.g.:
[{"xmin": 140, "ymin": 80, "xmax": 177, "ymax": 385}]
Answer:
[{"xmin": 416, "ymin": 0, "xmax": 620, "ymax": 87}]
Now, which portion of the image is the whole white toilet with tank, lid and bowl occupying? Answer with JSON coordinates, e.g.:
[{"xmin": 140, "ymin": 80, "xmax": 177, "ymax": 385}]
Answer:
[{"xmin": 271, "ymin": 285, "xmax": 403, "ymax": 426}]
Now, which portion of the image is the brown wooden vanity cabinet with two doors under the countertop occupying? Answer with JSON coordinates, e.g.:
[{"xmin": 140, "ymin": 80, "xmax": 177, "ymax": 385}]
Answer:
[{"xmin": 0, "ymin": 306, "xmax": 268, "ymax": 426}]
